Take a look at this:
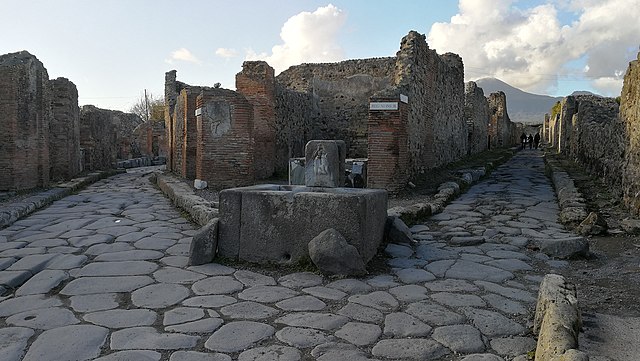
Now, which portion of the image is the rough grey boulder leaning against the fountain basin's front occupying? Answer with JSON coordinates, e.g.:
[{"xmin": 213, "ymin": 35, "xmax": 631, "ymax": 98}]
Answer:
[{"xmin": 309, "ymin": 228, "xmax": 367, "ymax": 276}]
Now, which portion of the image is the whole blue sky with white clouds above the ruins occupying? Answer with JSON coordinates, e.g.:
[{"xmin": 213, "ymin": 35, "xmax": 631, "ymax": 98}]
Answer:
[{"xmin": 0, "ymin": 0, "xmax": 640, "ymax": 110}]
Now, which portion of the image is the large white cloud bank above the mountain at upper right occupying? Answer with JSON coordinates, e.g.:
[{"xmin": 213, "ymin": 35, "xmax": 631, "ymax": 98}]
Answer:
[{"xmin": 428, "ymin": 0, "xmax": 640, "ymax": 95}]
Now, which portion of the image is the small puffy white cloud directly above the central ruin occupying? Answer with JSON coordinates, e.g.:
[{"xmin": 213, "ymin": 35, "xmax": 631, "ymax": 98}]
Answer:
[{"xmin": 246, "ymin": 4, "xmax": 346, "ymax": 74}]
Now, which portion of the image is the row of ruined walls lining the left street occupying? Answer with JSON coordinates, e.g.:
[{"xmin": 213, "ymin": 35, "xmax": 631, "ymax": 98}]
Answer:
[{"xmin": 0, "ymin": 51, "xmax": 164, "ymax": 191}]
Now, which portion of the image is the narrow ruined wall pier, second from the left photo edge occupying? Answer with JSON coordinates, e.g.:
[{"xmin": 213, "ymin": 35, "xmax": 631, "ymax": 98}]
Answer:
[{"xmin": 49, "ymin": 78, "xmax": 82, "ymax": 180}]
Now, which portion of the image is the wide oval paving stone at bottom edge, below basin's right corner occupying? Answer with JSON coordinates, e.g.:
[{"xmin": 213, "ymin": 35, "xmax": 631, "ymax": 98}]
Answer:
[{"xmin": 371, "ymin": 339, "xmax": 449, "ymax": 360}]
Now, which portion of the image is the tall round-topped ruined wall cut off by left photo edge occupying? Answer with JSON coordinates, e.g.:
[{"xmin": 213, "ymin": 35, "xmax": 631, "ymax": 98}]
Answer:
[{"xmin": 0, "ymin": 51, "xmax": 51, "ymax": 190}]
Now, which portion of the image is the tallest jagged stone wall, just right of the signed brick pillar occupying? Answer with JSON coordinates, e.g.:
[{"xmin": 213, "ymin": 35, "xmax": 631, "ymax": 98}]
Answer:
[{"xmin": 394, "ymin": 31, "xmax": 468, "ymax": 176}]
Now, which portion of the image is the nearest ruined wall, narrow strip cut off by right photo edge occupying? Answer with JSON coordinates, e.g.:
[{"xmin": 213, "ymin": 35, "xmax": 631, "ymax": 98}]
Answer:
[{"xmin": 620, "ymin": 53, "xmax": 640, "ymax": 215}]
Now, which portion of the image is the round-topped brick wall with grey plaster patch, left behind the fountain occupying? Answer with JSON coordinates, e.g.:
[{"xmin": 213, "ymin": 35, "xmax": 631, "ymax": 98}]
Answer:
[{"xmin": 196, "ymin": 89, "xmax": 255, "ymax": 189}]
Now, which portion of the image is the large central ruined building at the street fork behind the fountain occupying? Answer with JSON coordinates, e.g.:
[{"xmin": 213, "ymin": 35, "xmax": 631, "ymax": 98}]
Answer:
[{"xmin": 165, "ymin": 31, "xmax": 516, "ymax": 191}]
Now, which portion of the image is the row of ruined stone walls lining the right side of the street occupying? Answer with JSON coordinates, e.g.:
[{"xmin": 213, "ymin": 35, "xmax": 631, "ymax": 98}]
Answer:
[{"xmin": 542, "ymin": 50, "xmax": 640, "ymax": 215}]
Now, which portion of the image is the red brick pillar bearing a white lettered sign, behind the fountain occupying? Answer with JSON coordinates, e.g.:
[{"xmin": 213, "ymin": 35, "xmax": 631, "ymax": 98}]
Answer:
[{"xmin": 367, "ymin": 97, "xmax": 409, "ymax": 193}]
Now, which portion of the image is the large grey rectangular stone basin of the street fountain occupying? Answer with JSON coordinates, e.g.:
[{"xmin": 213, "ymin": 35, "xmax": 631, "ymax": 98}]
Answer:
[{"xmin": 217, "ymin": 184, "xmax": 387, "ymax": 263}]
